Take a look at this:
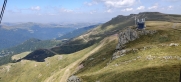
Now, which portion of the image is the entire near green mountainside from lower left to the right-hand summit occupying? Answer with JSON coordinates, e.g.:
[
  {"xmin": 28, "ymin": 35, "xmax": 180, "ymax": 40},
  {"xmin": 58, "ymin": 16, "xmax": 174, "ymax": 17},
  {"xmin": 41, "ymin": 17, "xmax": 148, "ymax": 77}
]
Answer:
[{"xmin": 0, "ymin": 12, "xmax": 181, "ymax": 82}]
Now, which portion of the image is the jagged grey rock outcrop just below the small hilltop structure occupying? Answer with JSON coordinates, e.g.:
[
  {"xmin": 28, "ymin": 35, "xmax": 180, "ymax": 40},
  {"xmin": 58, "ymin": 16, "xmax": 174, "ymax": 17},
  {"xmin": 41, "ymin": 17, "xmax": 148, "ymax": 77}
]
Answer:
[{"xmin": 112, "ymin": 28, "xmax": 156, "ymax": 59}]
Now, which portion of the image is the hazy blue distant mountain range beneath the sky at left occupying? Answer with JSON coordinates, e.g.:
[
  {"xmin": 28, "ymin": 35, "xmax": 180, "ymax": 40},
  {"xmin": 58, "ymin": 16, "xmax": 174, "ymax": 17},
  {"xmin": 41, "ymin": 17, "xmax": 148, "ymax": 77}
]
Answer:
[{"xmin": 0, "ymin": 22, "xmax": 99, "ymax": 50}]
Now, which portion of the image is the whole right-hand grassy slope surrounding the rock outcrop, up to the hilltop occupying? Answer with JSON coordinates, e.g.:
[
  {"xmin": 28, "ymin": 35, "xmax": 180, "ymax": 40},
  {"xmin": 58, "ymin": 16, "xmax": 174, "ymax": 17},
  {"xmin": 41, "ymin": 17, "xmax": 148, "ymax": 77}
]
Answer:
[{"xmin": 76, "ymin": 21, "xmax": 181, "ymax": 82}]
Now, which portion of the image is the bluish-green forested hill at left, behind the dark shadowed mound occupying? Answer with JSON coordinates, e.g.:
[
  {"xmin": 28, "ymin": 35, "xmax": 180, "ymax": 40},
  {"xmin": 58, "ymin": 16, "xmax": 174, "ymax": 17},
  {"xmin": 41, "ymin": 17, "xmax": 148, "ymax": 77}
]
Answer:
[{"xmin": 0, "ymin": 38, "xmax": 62, "ymax": 65}]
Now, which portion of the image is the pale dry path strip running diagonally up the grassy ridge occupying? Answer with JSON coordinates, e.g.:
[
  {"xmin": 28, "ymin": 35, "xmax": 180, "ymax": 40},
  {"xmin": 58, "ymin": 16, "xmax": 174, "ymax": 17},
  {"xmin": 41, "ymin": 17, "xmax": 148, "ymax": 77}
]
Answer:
[{"xmin": 44, "ymin": 34, "xmax": 118, "ymax": 82}]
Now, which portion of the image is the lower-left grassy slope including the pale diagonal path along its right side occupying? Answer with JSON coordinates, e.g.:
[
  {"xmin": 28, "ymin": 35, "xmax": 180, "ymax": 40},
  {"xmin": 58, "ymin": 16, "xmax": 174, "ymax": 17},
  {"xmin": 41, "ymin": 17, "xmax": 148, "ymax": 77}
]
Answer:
[{"xmin": 0, "ymin": 36, "xmax": 116, "ymax": 82}]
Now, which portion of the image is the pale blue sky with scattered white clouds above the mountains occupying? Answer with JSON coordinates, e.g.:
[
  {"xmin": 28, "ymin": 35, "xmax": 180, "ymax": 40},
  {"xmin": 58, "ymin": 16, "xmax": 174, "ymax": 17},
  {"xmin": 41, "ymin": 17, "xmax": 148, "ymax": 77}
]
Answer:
[{"xmin": 0, "ymin": 0, "xmax": 181, "ymax": 23}]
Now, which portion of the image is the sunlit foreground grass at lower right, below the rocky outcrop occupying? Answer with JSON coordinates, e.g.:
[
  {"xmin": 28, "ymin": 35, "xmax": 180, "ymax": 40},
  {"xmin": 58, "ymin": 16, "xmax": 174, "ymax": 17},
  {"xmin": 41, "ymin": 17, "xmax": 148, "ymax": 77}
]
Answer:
[{"xmin": 78, "ymin": 46, "xmax": 181, "ymax": 82}]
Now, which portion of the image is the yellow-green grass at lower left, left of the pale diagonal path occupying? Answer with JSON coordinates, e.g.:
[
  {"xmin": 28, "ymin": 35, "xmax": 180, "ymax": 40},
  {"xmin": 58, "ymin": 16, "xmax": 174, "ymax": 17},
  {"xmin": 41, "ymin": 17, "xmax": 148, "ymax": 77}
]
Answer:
[{"xmin": 0, "ymin": 41, "xmax": 97, "ymax": 82}]
